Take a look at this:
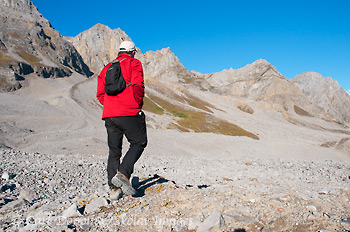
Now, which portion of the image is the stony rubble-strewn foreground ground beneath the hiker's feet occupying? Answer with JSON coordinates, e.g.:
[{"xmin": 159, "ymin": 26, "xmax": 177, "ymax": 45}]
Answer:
[{"xmin": 0, "ymin": 149, "xmax": 350, "ymax": 232}]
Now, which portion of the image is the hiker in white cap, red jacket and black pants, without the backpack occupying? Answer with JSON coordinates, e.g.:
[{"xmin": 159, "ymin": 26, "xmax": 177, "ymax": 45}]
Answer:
[{"xmin": 96, "ymin": 41, "xmax": 147, "ymax": 199}]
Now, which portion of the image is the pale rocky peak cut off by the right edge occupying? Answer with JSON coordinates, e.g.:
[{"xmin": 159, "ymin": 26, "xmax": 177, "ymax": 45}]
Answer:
[{"xmin": 292, "ymin": 72, "xmax": 350, "ymax": 123}]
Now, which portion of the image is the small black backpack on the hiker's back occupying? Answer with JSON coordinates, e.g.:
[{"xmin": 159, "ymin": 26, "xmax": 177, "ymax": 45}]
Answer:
[{"xmin": 105, "ymin": 58, "xmax": 131, "ymax": 96}]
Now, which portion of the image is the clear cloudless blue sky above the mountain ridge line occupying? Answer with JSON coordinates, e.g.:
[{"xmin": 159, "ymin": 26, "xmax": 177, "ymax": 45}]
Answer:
[{"xmin": 33, "ymin": 0, "xmax": 350, "ymax": 90}]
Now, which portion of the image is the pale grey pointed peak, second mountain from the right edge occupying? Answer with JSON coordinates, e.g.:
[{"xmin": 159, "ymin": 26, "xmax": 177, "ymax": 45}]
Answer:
[{"xmin": 206, "ymin": 59, "xmax": 325, "ymax": 117}]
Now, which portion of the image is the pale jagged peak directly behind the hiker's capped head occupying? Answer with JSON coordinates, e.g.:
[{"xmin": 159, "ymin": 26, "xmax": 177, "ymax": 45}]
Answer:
[{"xmin": 66, "ymin": 23, "xmax": 131, "ymax": 73}]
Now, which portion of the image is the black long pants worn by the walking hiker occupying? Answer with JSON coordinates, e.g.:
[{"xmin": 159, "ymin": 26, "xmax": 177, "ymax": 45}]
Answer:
[{"xmin": 105, "ymin": 111, "xmax": 147, "ymax": 187}]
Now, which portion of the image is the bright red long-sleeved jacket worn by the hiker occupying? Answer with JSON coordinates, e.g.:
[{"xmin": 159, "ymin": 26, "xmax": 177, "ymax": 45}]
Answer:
[{"xmin": 96, "ymin": 54, "xmax": 145, "ymax": 119}]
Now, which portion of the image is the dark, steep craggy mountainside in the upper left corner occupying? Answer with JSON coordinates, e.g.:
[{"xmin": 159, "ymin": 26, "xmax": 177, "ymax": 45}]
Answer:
[{"xmin": 0, "ymin": 0, "xmax": 92, "ymax": 90}]
